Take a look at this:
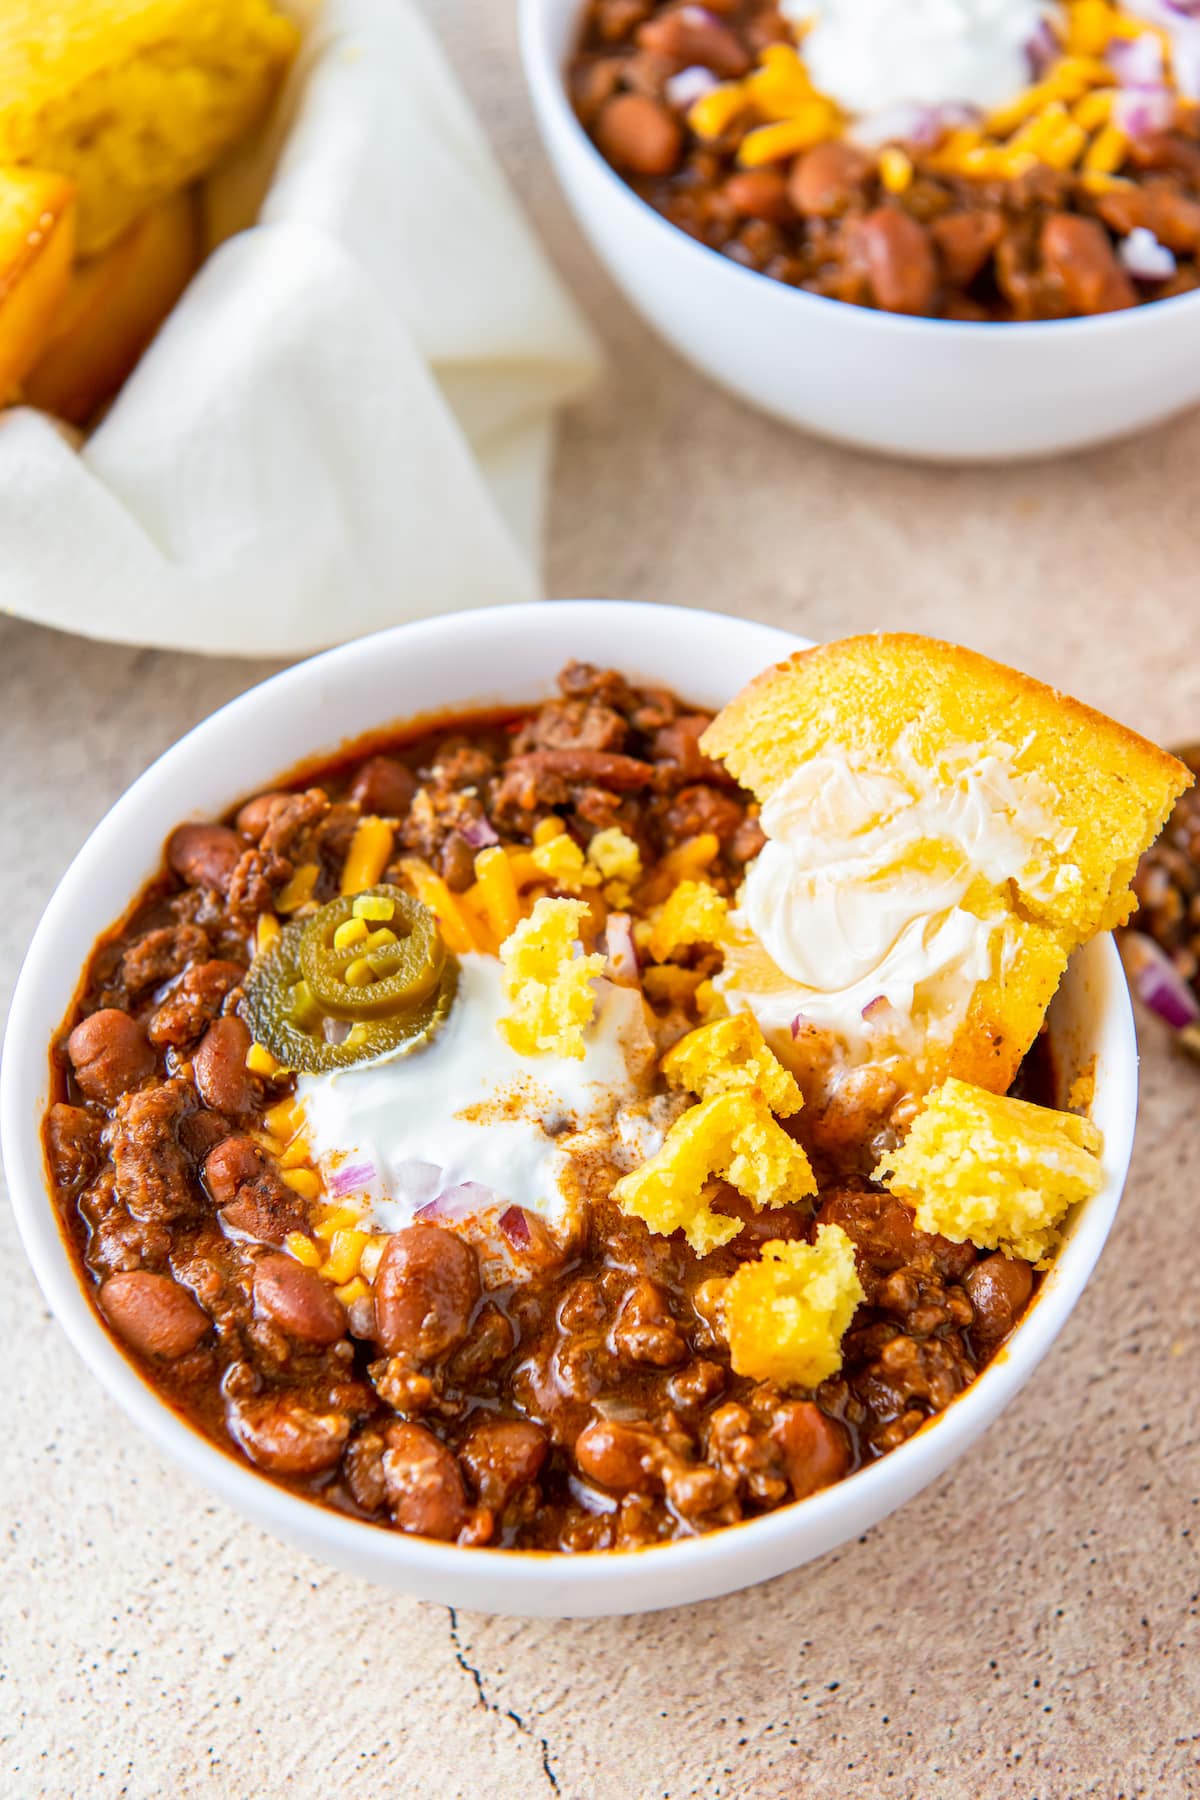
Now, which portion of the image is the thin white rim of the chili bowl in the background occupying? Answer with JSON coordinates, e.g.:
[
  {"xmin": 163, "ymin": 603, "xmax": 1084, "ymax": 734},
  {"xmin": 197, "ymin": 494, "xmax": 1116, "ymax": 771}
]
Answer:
[{"xmin": 516, "ymin": 0, "xmax": 1200, "ymax": 342}]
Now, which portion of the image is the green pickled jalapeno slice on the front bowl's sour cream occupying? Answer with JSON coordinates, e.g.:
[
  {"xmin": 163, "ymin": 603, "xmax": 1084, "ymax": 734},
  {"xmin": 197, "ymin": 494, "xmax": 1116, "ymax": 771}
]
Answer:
[{"xmin": 241, "ymin": 889, "xmax": 459, "ymax": 1075}]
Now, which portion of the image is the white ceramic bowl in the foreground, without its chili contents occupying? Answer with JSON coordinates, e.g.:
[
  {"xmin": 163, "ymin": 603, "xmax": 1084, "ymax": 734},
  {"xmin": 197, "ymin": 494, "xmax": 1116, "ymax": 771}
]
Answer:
[{"xmin": 0, "ymin": 601, "xmax": 1137, "ymax": 1616}]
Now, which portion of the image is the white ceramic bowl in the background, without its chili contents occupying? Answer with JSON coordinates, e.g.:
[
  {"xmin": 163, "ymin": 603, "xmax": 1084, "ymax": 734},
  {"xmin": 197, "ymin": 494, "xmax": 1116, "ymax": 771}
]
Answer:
[{"xmin": 520, "ymin": 0, "xmax": 1200, "ymax": 461}]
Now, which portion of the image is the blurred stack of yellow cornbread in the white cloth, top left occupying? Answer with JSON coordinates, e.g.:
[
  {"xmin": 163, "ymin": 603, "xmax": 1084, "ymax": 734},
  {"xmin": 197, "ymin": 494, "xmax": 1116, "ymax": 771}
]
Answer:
[{"xmin": 0, "ymin": 0, "xmax": 297, "ymax": 423}]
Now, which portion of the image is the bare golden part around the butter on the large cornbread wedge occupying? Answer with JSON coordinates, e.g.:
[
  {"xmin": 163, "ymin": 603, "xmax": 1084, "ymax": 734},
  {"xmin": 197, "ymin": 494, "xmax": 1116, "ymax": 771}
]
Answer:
[{"xmin": 702, "ymin": 634, "xmax": 1191, "ymax": 1093}]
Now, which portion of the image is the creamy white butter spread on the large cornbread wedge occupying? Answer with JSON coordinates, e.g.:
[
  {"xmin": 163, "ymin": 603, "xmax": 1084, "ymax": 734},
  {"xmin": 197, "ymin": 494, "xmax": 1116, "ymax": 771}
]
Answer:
[{"xmin": 718, "ymin": 745, "xmax": 1079, "ymax": 1051}]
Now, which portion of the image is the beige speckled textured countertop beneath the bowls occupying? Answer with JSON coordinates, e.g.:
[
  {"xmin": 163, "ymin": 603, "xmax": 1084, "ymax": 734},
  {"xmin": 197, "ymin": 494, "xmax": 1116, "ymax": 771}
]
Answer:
[{"xmin": 0, "ymin": 0, "xmax": 1200, "ymax": 1800}]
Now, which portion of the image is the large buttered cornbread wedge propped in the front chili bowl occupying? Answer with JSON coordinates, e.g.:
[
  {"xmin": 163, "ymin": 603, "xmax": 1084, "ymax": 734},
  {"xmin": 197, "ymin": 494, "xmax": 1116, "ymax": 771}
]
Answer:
[{"xmin": 700, "ymin": 634, "xmax": 1191, "ymax": 1093}]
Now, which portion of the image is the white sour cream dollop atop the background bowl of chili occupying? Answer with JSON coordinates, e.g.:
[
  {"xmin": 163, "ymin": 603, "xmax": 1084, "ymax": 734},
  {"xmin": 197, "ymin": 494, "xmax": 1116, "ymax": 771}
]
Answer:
[{"xmin": 781, "ymin": 0, "xmax": 1054, "ymax": 115}]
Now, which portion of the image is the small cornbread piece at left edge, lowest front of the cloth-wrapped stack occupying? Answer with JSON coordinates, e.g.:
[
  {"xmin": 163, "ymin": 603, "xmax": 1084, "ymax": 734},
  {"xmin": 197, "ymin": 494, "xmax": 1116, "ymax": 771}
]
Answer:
[{"xmin": 0, "ymin": 169, "xmax": 76, "ymax": 405}]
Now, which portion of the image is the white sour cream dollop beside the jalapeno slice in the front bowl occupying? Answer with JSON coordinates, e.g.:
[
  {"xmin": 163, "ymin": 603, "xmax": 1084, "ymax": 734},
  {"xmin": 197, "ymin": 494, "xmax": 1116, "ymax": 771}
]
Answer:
[{"xmin": 297, "ymin": 954, "xmax": 660, "ymax": 1238}]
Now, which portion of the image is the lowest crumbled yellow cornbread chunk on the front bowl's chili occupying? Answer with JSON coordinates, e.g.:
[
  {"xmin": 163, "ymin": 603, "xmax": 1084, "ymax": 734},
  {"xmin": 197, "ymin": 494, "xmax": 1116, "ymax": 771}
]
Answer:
[{"xmin": 720, "ymin": 1226, "xmax": 865, "ymax": 1388}]
